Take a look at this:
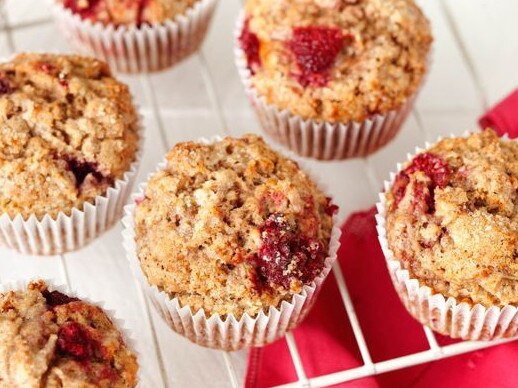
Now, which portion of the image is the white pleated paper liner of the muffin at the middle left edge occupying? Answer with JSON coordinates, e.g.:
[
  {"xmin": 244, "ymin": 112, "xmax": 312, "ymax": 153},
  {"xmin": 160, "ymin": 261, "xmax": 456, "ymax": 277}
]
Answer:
[{"xmin": 0, "ymin": 117, "xmax": 145, "ymax": 255}]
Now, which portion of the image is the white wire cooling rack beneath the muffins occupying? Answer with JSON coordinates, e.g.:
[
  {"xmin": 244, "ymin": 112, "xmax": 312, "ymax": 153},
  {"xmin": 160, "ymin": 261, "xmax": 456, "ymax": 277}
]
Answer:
[{"xmin": 0, "ymin": 0, "xmax": 513, "ymax": 388}]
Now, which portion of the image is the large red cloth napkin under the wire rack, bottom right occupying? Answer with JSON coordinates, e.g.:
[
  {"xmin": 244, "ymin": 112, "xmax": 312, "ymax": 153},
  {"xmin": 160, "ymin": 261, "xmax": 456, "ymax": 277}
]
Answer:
[{"xmin": 246, "ymin": 209, "xmax": 518, "ymax": 388}]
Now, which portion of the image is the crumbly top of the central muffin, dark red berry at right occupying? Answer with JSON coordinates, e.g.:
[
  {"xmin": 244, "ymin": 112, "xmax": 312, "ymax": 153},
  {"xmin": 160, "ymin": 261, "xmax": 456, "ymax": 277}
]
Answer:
[{"xmin": 135, "ymin": 135, "xmax": 337, "ymax": 317}]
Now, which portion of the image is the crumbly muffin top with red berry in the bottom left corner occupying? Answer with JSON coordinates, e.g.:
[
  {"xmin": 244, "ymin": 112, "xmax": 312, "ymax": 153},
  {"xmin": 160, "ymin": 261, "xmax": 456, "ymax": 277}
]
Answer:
[{"xmin": 0, "ymin": 281, "xmax": 138, "ymax": 388}]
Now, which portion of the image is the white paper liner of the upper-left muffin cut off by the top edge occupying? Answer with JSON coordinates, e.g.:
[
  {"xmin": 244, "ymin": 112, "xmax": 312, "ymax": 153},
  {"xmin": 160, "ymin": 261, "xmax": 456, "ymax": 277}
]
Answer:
[{"xmin": 53, "ymin": 0, "xmax": 221, "ymax": 73}]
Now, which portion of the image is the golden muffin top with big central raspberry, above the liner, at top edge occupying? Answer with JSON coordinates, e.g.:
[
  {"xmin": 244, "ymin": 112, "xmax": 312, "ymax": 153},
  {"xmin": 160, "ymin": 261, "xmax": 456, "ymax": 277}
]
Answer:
[{"xmin": 240, "ymin": 0, "xmax": 432, "ymax": 122}]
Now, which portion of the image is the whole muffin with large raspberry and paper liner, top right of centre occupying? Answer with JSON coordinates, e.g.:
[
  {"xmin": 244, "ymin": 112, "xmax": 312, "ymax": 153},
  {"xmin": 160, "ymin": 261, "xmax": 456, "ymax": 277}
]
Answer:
[{"xmin": 236, "ymin": 0, "xmax": 432, "ymax": 159}]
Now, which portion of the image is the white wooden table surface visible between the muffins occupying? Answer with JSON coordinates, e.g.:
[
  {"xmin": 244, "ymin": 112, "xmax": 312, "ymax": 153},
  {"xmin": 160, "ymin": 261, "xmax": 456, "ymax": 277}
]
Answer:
[{"xmin": 0, "ymin": 0, "xmax": 518, "ymax": 388}]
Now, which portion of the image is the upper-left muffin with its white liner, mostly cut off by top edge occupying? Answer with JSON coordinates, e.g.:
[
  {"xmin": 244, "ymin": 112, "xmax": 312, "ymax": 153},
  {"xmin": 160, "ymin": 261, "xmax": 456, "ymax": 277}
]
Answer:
[{"xmin": 51, "ymin": 0, "xmax": 217, "ymax": 73}]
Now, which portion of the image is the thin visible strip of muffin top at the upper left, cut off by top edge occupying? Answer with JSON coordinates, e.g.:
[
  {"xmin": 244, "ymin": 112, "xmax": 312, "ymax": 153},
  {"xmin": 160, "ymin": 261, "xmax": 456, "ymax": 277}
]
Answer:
[{"xmin": 57, "ymin": 0, "xmax": 199, "ymax": 26}]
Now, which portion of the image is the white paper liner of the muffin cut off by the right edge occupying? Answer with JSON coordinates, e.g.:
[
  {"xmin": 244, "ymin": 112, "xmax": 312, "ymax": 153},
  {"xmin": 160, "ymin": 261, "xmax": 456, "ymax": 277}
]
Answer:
[{"xmin": 376, "ymin": 135, "xmax": 518, "ymax": 340}]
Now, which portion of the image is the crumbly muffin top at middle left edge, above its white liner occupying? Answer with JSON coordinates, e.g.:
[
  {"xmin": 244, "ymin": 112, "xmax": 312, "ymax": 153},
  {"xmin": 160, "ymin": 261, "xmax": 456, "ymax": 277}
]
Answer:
[{"xmin": 0, "ymin": 54, "xmax": 138, "ymax": 218}]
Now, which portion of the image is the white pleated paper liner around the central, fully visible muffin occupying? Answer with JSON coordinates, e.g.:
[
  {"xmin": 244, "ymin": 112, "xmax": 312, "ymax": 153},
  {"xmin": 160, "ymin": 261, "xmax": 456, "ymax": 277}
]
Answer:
[{"xmin": 122, "ymin": 137, "xmax": 341, "ymax": 351}]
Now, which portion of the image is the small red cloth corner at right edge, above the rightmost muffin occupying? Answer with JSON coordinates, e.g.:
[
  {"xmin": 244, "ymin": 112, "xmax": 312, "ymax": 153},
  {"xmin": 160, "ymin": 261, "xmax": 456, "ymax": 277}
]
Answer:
[{"xmin": 479, "ymin": 89, "xmax": 518, "ymax": 138}]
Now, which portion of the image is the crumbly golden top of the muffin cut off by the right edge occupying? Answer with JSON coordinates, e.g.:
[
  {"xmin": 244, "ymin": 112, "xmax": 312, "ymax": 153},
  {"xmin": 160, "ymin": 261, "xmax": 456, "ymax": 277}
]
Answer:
[{"xmin": 386, "ymin": 130, "xmax": 518, "ymax": 306}]
